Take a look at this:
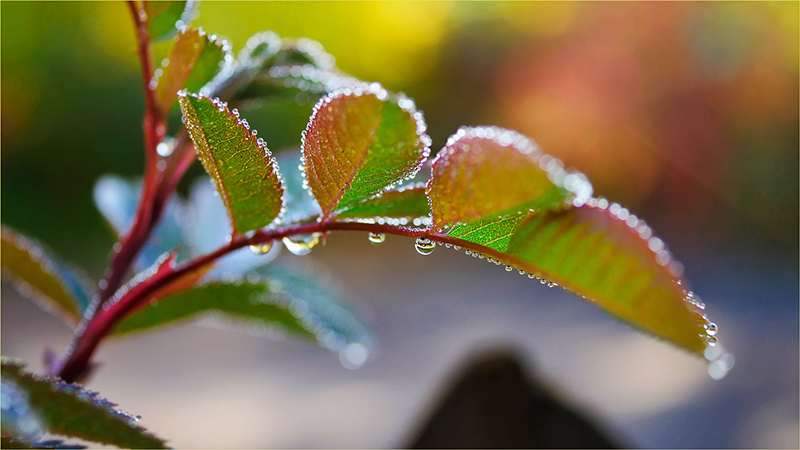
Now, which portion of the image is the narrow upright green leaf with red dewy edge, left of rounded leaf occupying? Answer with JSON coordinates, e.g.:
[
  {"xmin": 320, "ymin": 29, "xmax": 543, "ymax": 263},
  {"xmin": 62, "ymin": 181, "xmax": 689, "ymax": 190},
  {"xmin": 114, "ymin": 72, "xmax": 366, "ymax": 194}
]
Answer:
[{"xmin": 180, "ymin": 93, "xmax": 284, "ymax": 234}]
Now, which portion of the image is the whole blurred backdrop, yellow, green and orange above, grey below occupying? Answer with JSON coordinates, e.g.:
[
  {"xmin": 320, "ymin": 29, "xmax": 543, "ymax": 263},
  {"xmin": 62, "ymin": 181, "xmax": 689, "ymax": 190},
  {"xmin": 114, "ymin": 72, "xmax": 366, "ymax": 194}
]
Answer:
[{"xmin": 0, "ymin": 2, "xmax": 800, "ymax": 448}]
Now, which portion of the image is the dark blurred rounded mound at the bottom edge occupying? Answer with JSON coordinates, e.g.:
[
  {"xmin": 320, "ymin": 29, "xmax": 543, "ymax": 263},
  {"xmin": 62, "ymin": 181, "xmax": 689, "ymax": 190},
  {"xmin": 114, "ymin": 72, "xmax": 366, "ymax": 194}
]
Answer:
[{"xmin": 409, "ymin": 350, "xmax": 618, "ymax": 448}]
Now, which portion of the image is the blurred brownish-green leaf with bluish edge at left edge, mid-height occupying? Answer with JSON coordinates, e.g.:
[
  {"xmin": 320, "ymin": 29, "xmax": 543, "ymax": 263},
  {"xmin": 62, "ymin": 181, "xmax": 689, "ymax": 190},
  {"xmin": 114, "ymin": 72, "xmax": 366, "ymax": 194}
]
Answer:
[{"xmin": 2, "ymin": 226, "xmax": 94, "ymax": 323}]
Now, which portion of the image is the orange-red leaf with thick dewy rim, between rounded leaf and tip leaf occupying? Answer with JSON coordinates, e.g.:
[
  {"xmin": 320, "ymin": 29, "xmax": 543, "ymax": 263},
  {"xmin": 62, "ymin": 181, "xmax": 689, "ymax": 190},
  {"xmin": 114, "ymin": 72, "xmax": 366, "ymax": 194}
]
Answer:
[{"xmin": 428, "ymin": 127, "xmax": 592, "ymax": 228}]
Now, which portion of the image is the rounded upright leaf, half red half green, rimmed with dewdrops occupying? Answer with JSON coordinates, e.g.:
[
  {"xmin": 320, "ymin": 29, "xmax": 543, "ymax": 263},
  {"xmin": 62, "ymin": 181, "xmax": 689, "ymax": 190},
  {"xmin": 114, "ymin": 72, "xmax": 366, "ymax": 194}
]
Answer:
[{"xmin": 302, "ymin": 83, "xmax": 430, "ymax": 218}]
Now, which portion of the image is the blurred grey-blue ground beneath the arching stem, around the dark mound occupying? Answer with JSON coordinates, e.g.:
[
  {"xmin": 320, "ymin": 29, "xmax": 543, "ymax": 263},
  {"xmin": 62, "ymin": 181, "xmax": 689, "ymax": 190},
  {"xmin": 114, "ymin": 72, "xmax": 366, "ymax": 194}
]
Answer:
[{"xmin": 2, "ymin": 233, "xmax": 798, "ymax": 448}]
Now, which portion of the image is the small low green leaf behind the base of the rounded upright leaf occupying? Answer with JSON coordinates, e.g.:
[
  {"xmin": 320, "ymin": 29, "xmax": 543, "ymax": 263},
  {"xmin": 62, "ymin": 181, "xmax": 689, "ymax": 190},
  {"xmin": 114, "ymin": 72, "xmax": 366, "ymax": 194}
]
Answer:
[{"xmin": 336, "ymin": 185, "xmax": 431, "ymax": 219}]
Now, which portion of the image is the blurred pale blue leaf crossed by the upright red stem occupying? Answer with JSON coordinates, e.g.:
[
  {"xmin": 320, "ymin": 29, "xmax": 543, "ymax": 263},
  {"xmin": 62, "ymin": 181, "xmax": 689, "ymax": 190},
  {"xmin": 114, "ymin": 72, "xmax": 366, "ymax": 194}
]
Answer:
[{"xmin": 94, "ymin": 175, "xmax": 186, "ymax": 270}]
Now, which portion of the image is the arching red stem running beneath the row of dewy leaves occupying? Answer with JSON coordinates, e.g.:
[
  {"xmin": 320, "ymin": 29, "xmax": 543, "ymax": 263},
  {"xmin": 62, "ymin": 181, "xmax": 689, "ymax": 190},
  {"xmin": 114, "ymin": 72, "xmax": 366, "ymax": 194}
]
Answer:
[{"xmin": 54, "ymin": 222, "xmax": 501, "ymax": 382}]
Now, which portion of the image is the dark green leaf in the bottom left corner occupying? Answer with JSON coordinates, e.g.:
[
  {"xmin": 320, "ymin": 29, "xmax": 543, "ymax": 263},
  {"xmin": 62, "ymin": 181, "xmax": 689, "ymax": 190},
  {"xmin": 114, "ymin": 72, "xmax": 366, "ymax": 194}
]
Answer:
[{"xmin": 2, "ymin": 358, "xmax": 166, "ymax": 448}]
